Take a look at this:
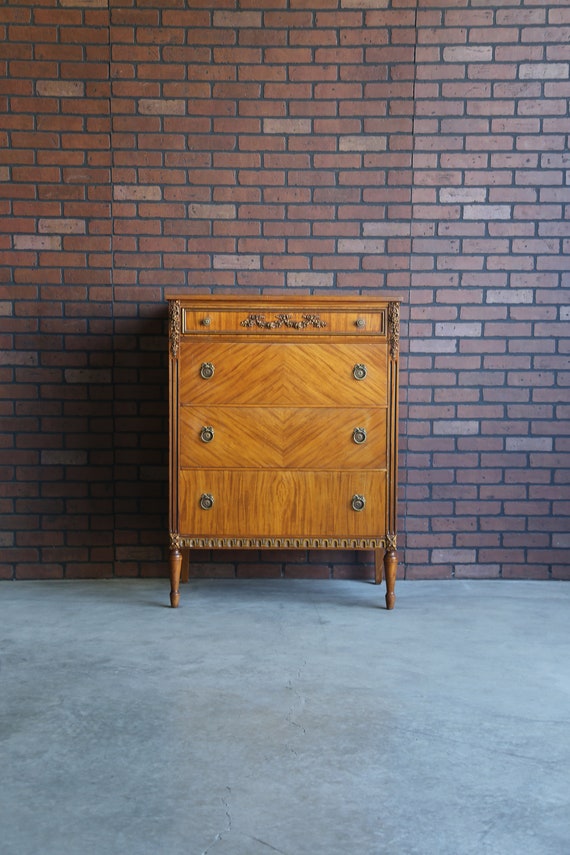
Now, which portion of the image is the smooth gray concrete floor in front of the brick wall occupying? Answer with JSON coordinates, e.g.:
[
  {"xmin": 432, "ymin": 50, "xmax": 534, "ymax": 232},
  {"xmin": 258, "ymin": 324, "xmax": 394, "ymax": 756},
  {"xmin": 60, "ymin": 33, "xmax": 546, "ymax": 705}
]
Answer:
[{"xmin": 0, "ymin": 580, "xmax": 570, "ymax": 855}]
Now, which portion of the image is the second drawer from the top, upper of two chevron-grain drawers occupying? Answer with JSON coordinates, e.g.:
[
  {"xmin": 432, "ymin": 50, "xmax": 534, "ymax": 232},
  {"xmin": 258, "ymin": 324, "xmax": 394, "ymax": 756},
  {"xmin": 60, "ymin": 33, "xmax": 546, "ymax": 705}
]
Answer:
[{"xmin": 179, "ymin": 338, "xmax": 387, "ymax": 407}]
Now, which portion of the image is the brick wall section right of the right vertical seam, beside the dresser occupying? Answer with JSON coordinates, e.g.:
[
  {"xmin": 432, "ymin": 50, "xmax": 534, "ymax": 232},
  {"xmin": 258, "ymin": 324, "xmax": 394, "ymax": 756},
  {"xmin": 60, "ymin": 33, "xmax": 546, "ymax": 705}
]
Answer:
[{"xmin": 404, "ymin": 0, "xmax": 570, "ymax": 579}]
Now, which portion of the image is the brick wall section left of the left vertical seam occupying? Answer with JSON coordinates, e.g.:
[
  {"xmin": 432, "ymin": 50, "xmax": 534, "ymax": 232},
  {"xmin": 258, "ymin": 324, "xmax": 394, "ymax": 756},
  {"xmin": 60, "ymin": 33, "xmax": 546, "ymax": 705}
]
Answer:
[{"xmin": 0, "ymin": 2, "xmax": 114, "ymax": 579}]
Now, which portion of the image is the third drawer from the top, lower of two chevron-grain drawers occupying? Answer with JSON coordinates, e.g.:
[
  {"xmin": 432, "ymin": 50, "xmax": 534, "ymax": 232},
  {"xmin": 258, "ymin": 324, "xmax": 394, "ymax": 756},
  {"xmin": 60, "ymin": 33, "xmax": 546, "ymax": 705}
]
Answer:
[{"xmin": 180, "ymin": 406, "xmax": 386, "ymax": 469}]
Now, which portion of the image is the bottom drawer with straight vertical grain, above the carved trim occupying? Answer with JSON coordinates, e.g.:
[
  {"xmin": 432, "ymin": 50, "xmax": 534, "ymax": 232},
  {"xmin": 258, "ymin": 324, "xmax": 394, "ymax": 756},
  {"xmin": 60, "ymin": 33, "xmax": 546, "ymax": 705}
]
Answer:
[{"xmin": 178, "ymin": 469, "xmax": 386, "ymax": 538}]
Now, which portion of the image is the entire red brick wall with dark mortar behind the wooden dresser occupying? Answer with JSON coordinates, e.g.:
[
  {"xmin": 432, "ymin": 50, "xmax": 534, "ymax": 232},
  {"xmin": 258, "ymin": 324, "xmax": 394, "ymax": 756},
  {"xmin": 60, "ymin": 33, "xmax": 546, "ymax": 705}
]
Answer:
[{"xmin": 0, "ymin": 0, "xmax": 570, "ymax": 578}]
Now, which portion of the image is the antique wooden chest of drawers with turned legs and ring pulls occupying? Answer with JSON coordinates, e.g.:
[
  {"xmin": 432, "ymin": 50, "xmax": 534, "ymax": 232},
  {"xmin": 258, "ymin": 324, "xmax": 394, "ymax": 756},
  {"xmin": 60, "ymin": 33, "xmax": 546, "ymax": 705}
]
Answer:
[{"xmin": 168, "ymin": 295, "xmax": 399, "ymax": 608}]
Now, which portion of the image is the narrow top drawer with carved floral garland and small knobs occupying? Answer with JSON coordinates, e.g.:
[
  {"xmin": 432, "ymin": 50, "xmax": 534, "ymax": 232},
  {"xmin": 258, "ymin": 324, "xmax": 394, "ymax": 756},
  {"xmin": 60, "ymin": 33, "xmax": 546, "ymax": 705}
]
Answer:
[{"xmin": 181, "ymin": 306, "xmax": 387, "ymax": 336}]
